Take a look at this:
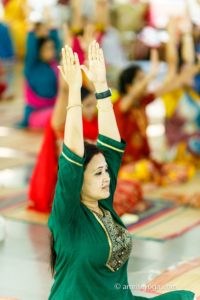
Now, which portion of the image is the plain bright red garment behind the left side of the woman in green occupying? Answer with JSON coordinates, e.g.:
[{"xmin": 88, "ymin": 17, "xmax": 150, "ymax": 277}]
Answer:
[{"xmin": 29, "ymin": 121, "xmax": 58, "ymax": 212}]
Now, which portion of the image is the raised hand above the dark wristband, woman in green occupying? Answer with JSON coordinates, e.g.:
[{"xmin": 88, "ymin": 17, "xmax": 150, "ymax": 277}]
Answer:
[{"xmin": 81, "ymin": 41, "xmax": 107, "ymax": 87}]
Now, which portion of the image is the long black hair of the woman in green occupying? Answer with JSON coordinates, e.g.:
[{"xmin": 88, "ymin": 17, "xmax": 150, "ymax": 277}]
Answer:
[{"xmin": 50, "ymin": 142, "xmax": 103, "ymax": 275}]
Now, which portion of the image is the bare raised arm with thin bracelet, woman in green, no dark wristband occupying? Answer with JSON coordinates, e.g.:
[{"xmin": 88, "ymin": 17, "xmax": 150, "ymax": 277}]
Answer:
[{"xmin": 59, "ymin": 46, "xmax": 84, "ymax": 157}]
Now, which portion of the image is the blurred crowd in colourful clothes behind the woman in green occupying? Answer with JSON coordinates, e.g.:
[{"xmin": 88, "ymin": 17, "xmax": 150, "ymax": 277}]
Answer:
[{"xmin": 0, "ymin": 0, "xmax": 200, "ymax": 214}]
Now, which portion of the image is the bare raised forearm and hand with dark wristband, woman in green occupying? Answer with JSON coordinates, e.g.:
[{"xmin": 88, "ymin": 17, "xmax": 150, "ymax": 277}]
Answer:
[{"xmin": 82, "ymin": 41, "xmax": 121, "ymax": 141}]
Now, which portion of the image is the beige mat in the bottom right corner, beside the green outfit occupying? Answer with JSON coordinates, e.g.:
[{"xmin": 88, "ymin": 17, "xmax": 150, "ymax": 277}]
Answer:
[{"xmin": 145, "ymin": 258, "xmax": 200, "ymax": 300}]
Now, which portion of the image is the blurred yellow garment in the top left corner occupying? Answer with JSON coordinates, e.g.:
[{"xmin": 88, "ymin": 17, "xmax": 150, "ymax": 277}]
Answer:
[{"xmin": 4, "ymin": 0, "xmax": 27, "ymax": 58}]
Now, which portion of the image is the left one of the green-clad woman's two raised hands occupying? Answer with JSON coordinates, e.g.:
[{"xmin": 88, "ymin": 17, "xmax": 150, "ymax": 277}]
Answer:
[{"xmin": 58, "ymin": 45, "xmax": 82, "ymax": 89}]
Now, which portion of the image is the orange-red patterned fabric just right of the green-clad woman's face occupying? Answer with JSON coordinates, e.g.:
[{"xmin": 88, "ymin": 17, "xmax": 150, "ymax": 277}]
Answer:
[{"xmin": 113, "ymin": 179, "xmax": 143, "ymax": 216}]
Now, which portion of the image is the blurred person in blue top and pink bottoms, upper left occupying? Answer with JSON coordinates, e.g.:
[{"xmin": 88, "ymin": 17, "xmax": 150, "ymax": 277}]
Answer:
[{"xmin": 18, "ymin": 23, "xmax": 59, "ymax": 128}]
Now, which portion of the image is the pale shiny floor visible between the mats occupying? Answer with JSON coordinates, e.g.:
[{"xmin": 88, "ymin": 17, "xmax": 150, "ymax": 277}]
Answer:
[{"xmin": 0, "ymin": 67, "xmax": 200, "ymax": 300}]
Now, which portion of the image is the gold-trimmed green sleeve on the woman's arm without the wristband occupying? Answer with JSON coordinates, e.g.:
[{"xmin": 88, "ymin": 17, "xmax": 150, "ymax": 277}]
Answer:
[{"xmin": 50, "ymin": 144, "xmax": 84, "ymax": 228}]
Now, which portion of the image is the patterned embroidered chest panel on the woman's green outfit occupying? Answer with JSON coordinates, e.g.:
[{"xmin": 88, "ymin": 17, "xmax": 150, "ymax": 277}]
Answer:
[{"xmin": 94, "ymin": 209, "xmax": 132, "ymax": 272}]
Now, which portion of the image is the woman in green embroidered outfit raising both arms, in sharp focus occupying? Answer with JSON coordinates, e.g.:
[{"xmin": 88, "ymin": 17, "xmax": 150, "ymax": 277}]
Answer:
[{"xmin": 49, "ymin": 41, "xmax": 194, "ymax": 300}]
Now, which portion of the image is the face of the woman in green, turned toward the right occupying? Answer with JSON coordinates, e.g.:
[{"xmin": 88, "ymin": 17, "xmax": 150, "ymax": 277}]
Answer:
[{"xmin": 81, "ymin": 153, "xmax": 110, "ymax": 202}]
